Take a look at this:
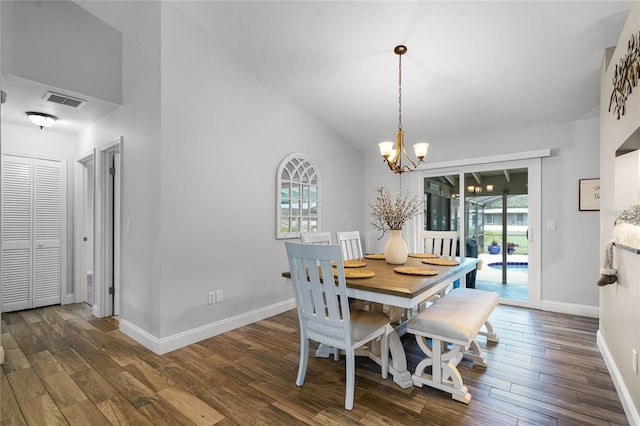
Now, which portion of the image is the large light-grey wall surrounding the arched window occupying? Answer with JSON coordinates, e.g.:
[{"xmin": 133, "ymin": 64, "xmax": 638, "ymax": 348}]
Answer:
[{"xmin": 161, "ymin": 3, "xmax": 363, "ymax": 337}]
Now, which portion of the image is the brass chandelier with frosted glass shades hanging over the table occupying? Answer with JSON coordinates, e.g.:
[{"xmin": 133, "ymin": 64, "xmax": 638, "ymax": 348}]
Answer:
[{"xmin": 378, "ymin": 45, "xmax": 429, "ymax": 173}]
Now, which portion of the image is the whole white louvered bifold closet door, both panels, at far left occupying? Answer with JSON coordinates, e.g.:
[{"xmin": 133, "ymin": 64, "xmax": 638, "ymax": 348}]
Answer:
[{"xmin": 1, "ymin": 155, "xmax": 63, "ymax": 312}]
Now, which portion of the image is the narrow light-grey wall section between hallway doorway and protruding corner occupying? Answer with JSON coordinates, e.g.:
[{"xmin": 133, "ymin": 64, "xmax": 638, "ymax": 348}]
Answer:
[{"xmin": 77, "ymin": 2, "xmax": 162, "ymax": 336}]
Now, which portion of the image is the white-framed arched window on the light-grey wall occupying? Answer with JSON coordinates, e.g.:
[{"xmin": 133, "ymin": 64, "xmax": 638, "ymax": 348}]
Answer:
[{"xmin": 276, "ymin": 153, "xmax": 320, "ymax": 239}]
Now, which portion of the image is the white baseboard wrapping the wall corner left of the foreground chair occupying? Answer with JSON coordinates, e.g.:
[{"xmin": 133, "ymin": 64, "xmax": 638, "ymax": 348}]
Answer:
[{"xmin": 120, "ymin": 299, "xmax": 296, "ymax": 355}]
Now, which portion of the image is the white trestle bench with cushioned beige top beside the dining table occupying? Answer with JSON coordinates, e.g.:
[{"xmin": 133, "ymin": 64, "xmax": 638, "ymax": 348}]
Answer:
[{"xmin": 407, "ymin": 288, "xmax": 500, "ymax": 404}]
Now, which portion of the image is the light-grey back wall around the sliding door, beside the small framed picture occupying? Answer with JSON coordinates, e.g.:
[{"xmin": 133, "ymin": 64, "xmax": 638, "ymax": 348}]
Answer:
[{"xmin": 364, "ymin": 118, "xmax": 599, "ymax": 313}]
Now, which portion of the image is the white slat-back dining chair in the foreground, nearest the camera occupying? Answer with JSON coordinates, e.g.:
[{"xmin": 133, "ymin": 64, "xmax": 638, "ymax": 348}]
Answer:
[{"xmin": 285, "ymin": 242, "xmax": 393, "ymax": 410}]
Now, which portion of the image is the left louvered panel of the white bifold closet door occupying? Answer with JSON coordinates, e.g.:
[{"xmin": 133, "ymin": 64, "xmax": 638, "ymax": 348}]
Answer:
[{"xmin": 0, "ymin": 156, "xmax": 33, "ymax": 312}]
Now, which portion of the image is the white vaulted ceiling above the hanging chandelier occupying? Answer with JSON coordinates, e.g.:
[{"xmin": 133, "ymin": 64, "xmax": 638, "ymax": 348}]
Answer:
[{"xmin": 3, "ymin": 1, "xmax": 632, "ymax": 152}]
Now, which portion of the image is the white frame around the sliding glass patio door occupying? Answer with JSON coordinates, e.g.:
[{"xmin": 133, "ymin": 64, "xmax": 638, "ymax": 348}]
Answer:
[{"xmin": 401, "ymin": 149, "xmax": 551, "ymax": 309}]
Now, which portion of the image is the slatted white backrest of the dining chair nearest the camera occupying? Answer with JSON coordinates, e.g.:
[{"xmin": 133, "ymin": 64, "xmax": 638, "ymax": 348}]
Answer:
[{"xmin": 285, "ymin": 242, "xmax": 351, "ymax": 347}]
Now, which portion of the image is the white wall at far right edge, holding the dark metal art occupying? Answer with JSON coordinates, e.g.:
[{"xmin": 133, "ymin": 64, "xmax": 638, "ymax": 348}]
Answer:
[{"xmin": 598, "ymin": 2, "xmax": 640, "ymax": 424}]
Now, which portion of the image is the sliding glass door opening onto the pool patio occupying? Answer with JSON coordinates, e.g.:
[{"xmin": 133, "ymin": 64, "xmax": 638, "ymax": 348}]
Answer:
[{"xmin": 422, "ymin": 159, "xmax": 540, "ymax": 307}]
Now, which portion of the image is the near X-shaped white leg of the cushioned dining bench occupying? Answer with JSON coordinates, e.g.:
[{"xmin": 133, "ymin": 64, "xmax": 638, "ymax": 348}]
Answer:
[{"xmin": 411, "ymin": 335, "xmax": 471, "ymax": 404}]
